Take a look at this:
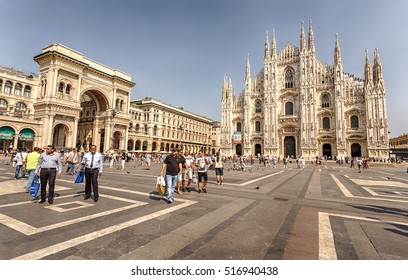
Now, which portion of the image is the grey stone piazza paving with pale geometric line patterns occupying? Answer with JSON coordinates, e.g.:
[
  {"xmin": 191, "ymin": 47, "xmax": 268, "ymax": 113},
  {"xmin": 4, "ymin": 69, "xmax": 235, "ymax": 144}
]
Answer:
[{"xmin": 0, "ymin": 160, "xmax": 408, "ymax": 260}]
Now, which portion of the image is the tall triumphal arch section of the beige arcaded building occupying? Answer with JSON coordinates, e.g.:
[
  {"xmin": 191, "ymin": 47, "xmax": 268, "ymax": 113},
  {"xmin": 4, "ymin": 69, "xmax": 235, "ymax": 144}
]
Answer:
[{"xmin": 34, "ymin": 44, "xmax": 135, "ymax": 151}]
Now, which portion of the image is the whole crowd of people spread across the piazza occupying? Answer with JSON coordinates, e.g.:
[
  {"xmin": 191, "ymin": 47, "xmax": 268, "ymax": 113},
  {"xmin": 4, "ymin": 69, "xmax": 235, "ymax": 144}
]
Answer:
[{"xmin": 4, "ymin": 145, "xmax": 400, "ymax": 204}]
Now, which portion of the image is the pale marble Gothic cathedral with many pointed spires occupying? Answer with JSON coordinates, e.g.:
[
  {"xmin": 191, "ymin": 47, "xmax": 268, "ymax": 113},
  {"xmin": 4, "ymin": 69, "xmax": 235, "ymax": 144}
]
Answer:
[{"xmin": 220, "ymin": 22, "xmax": 389, "ymax": 159}]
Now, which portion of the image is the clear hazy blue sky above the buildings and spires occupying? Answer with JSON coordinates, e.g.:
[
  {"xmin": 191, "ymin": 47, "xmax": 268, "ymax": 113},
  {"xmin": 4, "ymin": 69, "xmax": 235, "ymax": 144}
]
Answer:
[{"xmin": 0, "ymin": 0, "xmax": 408, "ymax": 136}]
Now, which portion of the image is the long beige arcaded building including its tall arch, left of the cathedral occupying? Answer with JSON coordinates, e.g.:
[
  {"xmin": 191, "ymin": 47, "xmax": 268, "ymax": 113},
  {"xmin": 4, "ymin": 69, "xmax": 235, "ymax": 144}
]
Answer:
[{"xmin": 0, "ymin": 44, "xmax": 214, "ymax": 153}]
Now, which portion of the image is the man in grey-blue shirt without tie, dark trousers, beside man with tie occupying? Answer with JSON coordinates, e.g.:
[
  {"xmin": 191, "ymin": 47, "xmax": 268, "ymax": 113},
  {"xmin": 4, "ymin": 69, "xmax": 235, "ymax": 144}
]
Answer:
[{"xmin": 34, "ymin": 145, "xmax": 62, "ymax": 204}]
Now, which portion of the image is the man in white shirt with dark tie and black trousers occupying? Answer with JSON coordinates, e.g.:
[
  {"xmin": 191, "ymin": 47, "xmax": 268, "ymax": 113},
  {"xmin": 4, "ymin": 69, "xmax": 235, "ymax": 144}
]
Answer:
[{"xmin": 81, "ymin": 145, "xmax": 103, "ymax": 202}]
